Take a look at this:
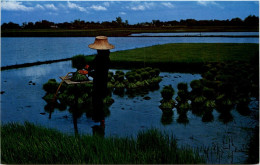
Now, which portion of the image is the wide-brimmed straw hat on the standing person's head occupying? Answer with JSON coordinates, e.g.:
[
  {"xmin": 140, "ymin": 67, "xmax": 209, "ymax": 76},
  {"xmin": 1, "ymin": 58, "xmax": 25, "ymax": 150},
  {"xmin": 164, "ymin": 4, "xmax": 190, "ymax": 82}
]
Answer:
[{"xmin": 88, "ymin": 36, "xmax": 115, "ymax": 50}]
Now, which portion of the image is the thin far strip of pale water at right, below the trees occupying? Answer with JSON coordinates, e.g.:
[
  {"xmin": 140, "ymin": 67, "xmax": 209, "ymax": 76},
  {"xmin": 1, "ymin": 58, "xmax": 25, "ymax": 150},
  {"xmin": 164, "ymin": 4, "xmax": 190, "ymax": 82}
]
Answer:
[{"xmin": 130, "ymin": 32, "xmax": 259, "ymax": 37}]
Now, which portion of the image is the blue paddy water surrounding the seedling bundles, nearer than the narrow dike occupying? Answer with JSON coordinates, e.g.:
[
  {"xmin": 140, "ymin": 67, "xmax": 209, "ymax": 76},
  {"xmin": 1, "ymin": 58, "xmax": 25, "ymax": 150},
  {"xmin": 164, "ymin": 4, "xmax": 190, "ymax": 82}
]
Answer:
[{"xmin": 1, "ymin": 61, "xmax": 258, "ymax": 163}]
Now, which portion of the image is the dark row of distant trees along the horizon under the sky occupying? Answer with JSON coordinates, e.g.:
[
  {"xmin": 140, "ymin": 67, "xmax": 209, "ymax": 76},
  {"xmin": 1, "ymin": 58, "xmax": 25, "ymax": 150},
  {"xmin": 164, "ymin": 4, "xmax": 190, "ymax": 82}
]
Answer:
[{"xmin": 1, "ymin": 15, "xmax": 259, "ymax": 30}]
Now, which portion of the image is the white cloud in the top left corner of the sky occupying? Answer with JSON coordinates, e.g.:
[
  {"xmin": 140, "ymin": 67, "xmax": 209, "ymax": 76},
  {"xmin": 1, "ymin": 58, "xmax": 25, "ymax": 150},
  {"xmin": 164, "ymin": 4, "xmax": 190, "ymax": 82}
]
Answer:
[{"xmin": 1, "ymin": 1, "xmax": 33, "ymax": 11}]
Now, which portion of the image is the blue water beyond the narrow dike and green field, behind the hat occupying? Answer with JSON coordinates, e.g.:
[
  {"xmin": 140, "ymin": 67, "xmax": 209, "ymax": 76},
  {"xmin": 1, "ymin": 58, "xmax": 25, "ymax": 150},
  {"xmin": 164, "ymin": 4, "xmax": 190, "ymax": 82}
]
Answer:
[{"xmin": 1, "ymin": 37, "xmax": 259, "ymax": 66}]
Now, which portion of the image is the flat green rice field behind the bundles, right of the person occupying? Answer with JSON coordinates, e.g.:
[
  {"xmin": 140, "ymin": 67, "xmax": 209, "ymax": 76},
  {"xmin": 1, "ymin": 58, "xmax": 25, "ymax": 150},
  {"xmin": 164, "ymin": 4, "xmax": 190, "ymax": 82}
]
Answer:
[{"xmin": 86, "ymin": 43, "xmax": 259, "ymax": 72}]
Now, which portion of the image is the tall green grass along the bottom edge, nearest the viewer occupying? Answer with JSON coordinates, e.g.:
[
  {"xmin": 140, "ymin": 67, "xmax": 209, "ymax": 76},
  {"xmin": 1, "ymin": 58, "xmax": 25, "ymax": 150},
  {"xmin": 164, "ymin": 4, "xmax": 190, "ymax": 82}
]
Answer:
[{"xmin": 1, "ymin": 122, "xmax": 205, "ymax": 164}]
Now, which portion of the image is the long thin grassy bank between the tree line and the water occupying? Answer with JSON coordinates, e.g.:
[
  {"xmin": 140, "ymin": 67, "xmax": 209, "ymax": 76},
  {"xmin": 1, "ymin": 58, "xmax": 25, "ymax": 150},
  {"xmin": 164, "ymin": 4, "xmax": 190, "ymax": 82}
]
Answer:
[{"xmin": 1, "ymin": 26, "xmax": 259, "ymax": 37}]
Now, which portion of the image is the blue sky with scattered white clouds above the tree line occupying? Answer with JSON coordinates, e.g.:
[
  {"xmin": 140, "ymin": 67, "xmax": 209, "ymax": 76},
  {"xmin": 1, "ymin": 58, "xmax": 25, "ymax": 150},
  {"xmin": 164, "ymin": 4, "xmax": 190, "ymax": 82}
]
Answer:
[{"xmin": 1, "ymin": 0, "xmax": 259, "ymax": 24}]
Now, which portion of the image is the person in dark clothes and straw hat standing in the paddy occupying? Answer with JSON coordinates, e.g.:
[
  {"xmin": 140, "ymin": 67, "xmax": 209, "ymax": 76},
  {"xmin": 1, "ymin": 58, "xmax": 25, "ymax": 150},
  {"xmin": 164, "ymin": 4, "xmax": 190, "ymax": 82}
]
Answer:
[{"xmin": 88, "ymin": 36, "xmax": 114, "ymax": 125}]
